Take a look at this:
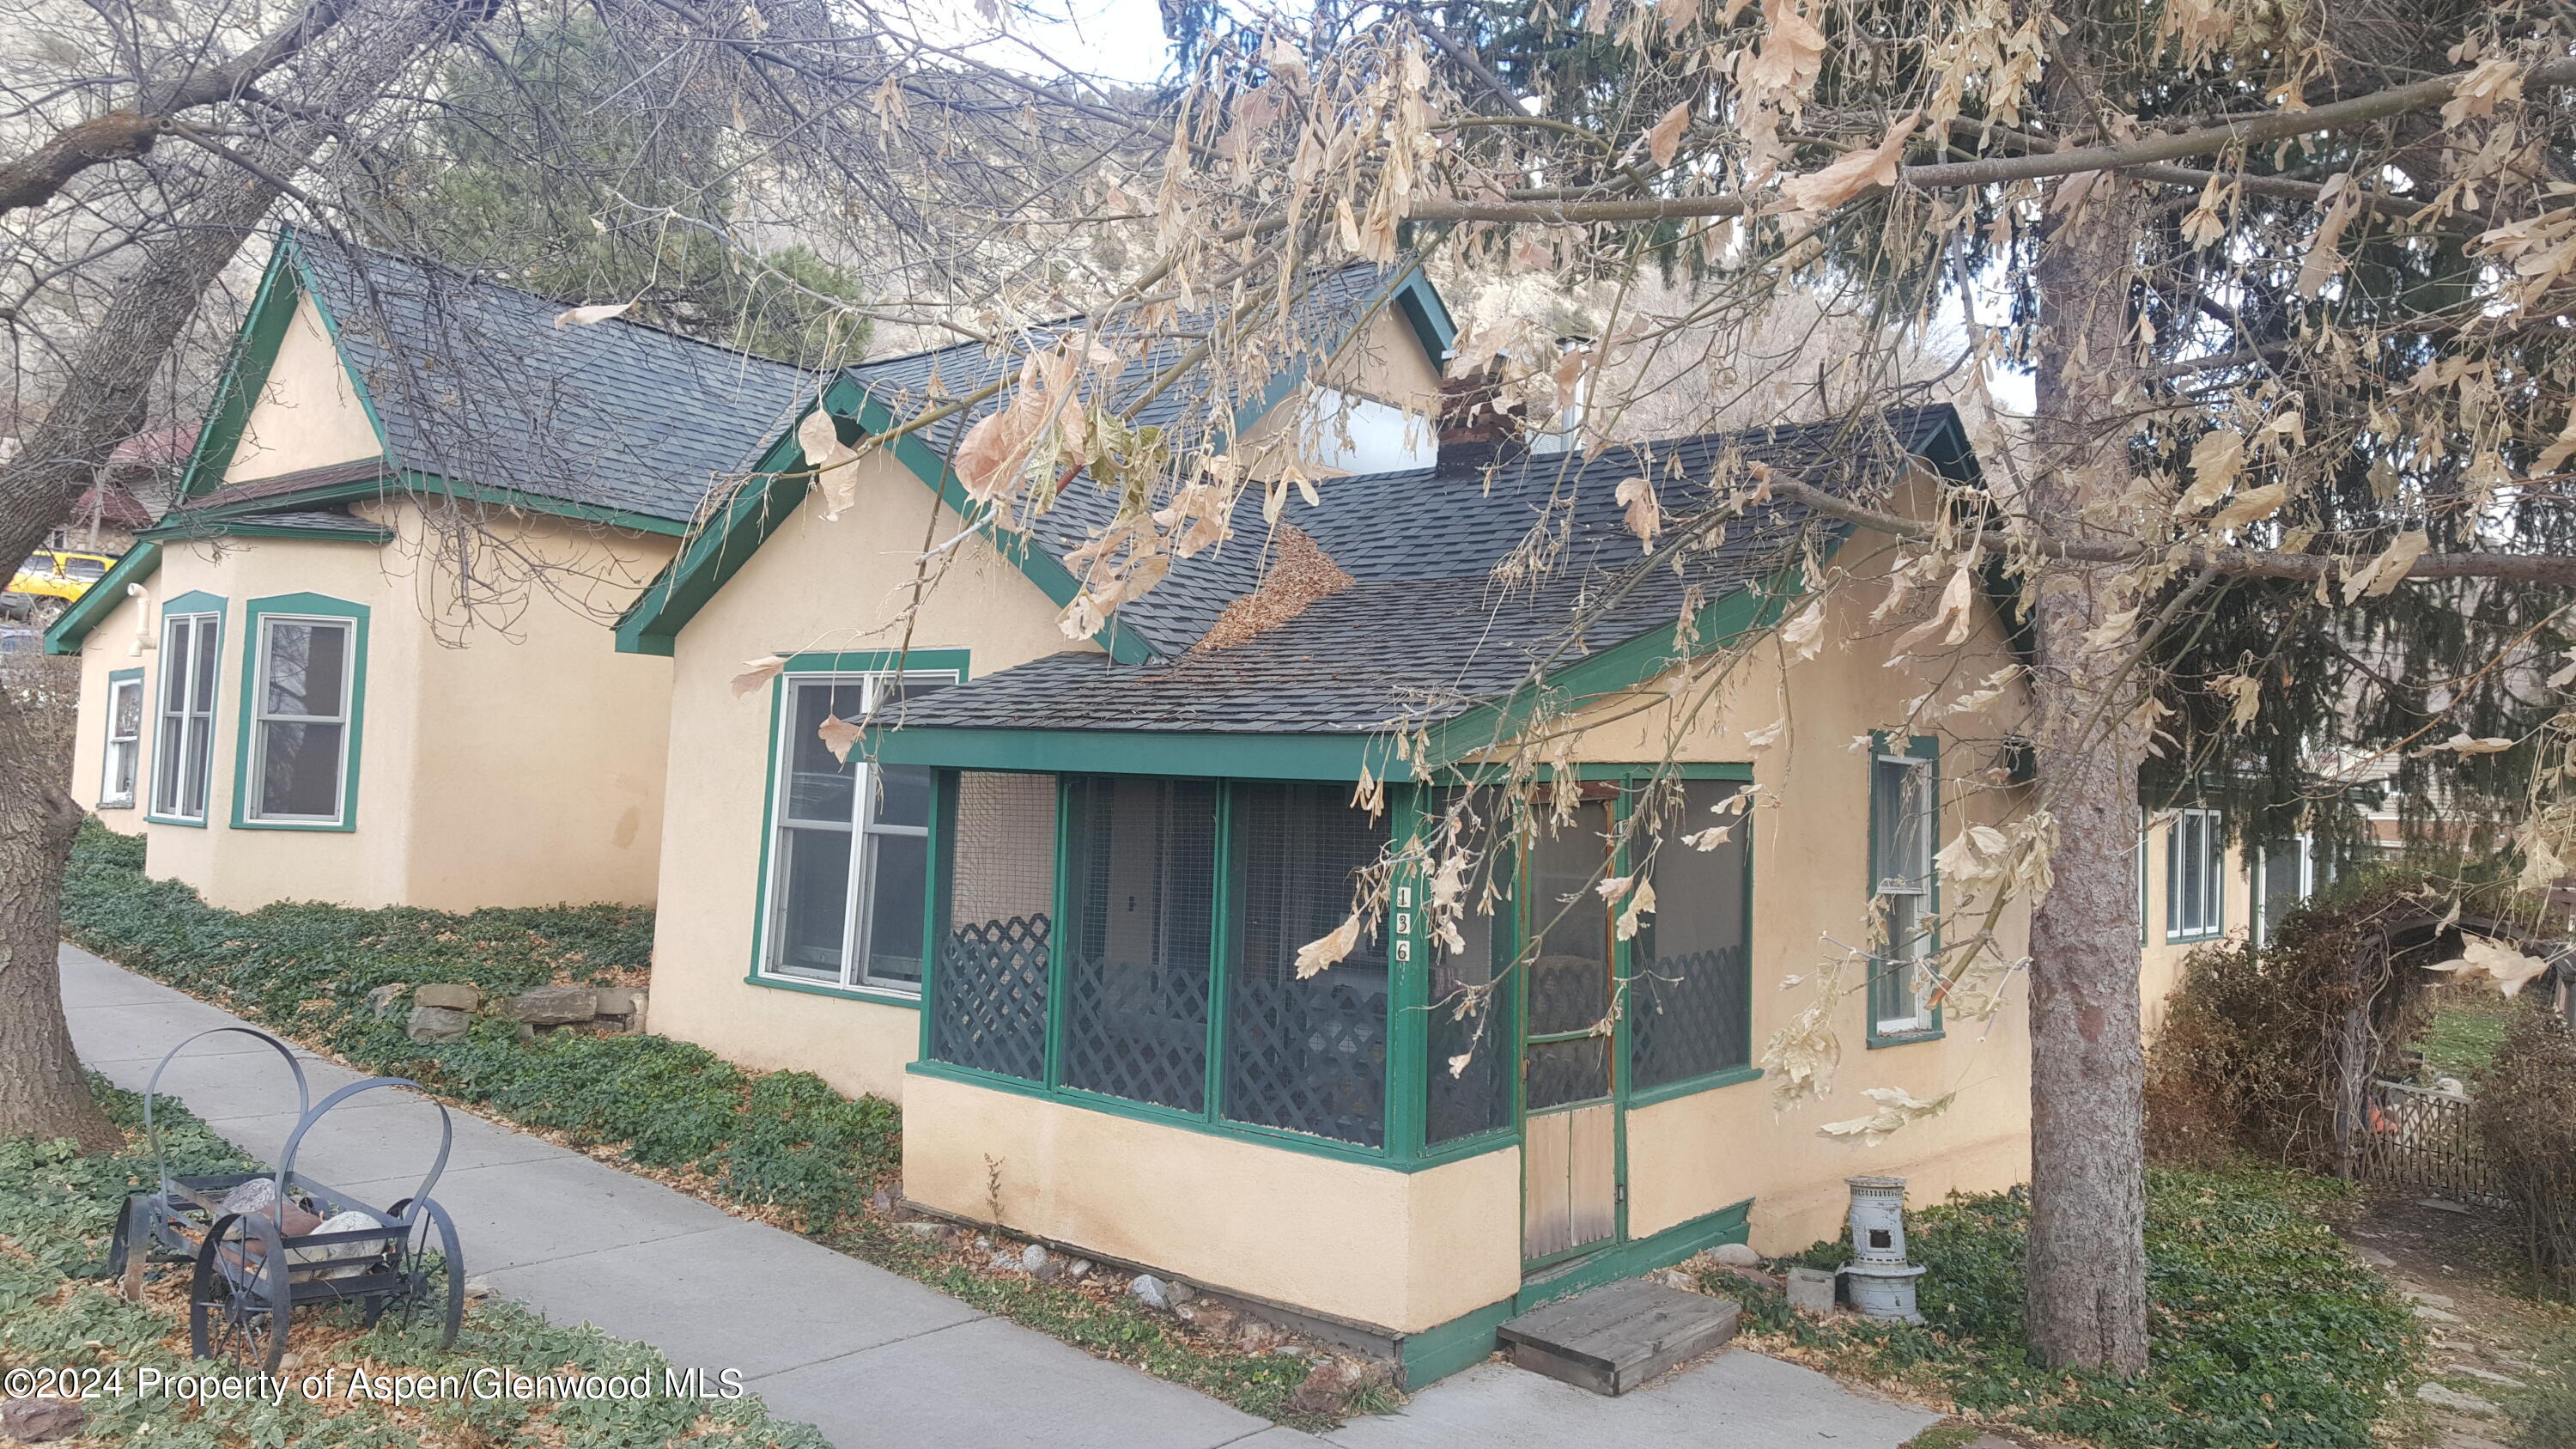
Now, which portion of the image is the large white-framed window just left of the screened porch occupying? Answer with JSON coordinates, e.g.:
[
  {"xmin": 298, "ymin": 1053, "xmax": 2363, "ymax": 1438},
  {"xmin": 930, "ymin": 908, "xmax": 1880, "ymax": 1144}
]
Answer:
[{"xmin": 760, "ymin": 670, "xmax": 956, "ymax": 993}]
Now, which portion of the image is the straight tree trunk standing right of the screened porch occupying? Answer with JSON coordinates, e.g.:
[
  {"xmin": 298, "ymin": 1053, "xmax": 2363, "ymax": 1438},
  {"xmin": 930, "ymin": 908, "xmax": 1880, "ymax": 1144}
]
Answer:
[{"xmin": 2025, "ymin": 47, "xmax": 2146, "ymax": 1374}]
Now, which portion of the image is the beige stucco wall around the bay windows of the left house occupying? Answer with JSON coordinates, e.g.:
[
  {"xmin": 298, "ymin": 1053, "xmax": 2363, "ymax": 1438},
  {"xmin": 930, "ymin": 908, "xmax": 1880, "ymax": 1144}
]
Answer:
[{"xmin": 72, "ymin": 502, "xmax": 670, "ymax": 910}]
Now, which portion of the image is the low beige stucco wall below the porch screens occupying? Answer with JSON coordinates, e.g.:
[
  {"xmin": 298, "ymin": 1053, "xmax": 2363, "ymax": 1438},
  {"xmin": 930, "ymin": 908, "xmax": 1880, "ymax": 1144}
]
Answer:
[{"xmin": 904, "ymin": 1075, "xmax": 1520, "ymax": 1333}]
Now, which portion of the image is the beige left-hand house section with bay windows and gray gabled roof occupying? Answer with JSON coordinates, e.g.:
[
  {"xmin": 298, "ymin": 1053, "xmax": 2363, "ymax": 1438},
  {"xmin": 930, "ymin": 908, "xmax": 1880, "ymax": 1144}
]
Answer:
[{"xmin": 46, "ymin": 232, "xmax": 801, "ymax": 910}]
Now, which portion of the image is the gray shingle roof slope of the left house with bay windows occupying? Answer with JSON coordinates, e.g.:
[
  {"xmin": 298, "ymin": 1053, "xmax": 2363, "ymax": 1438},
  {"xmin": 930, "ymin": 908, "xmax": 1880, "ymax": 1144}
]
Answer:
[{"xmin": 291, "ymin": 232, "xmax": 811, "ymax": 523}]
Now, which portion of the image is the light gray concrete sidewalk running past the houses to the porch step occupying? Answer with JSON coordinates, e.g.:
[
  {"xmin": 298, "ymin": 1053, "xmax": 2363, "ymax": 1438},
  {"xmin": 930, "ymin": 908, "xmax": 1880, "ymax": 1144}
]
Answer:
[{"xmin": 62, "ymin": 947, "xmax": 1935, "ymax": 1449}]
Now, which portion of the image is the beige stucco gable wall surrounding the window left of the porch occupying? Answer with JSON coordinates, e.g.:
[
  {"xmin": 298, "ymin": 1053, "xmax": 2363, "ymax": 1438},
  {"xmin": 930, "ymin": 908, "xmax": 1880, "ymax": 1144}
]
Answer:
[{"xmin": 652, "ymin": 454, "xmax": 1090, "ymax": 1099}]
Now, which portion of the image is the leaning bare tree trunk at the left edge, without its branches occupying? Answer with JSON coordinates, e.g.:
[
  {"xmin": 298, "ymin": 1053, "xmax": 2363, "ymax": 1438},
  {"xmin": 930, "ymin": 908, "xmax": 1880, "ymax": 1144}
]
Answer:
[{"xmin": 0, "ymin": 0, "xmax": 479, "ymax": 1145}]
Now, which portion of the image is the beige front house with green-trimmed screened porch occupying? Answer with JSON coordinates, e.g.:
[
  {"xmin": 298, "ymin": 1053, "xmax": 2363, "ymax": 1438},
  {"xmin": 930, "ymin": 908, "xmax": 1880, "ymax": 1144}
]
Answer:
[{"xmin": 621, "ymin": 256, "xmax": 2030, "ymax": 1385}]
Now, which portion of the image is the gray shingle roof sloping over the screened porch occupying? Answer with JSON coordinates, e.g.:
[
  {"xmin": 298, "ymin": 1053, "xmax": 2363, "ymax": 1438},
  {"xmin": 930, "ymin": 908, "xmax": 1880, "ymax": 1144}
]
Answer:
[{"xmin": 902, "ymin": 407, "xmax": 1958, "ymax": 735}]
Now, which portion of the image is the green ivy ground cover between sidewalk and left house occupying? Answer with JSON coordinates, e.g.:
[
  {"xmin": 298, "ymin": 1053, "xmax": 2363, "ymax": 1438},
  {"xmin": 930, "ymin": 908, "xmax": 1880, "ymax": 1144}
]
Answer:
[{"xmin": 62, "ymin": 820, "xmax": 899, "ymax": 1227}]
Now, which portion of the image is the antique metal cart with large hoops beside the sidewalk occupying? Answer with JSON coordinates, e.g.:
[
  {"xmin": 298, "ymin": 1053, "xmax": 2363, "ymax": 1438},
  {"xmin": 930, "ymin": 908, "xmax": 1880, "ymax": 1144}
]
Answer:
[{"xmin": 108, "ymin": 1026, "xmax": 466, "ymax": 1374}]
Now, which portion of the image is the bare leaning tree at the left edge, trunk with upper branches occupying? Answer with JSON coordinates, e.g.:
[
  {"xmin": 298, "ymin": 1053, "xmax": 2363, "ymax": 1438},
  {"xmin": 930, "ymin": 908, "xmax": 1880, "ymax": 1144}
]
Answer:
[{"xmin": 0, "ymin": 0, "xmax": 492, "ymax": 1145}]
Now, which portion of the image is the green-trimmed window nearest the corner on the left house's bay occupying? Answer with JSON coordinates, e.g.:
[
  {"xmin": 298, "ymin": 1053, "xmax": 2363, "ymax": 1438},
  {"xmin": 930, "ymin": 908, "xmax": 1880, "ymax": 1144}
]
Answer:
[{"xmin": 242, "ymin": 613, "xmax": 358, "ymax": 825}]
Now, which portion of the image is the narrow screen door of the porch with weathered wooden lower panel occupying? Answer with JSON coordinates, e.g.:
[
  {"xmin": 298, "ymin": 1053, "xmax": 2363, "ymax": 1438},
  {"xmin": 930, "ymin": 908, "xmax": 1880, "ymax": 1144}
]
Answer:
[{"xmin": 1520, "ymin": 792, "xmax": 1618, "ymax": 1263}]
